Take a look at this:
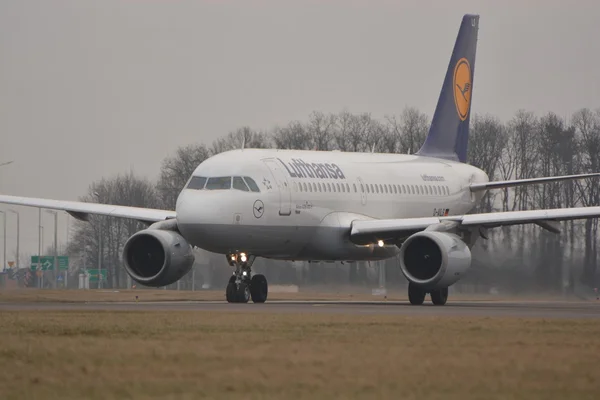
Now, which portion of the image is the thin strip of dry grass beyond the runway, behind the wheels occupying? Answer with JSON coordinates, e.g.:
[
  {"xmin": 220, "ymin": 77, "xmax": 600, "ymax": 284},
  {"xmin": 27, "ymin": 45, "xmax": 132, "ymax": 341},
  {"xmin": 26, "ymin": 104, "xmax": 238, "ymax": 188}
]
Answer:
[{"xmin": 0, "ymin": 288, "xmax": 578, "ymax": 303}]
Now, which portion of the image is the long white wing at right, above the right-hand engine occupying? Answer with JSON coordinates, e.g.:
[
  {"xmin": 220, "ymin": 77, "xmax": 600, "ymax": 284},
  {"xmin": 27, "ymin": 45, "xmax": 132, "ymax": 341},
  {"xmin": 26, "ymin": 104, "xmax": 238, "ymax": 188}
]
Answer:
[{"xmin": 350, "ymin": 207, "xmax": 600, "ymax": 244}]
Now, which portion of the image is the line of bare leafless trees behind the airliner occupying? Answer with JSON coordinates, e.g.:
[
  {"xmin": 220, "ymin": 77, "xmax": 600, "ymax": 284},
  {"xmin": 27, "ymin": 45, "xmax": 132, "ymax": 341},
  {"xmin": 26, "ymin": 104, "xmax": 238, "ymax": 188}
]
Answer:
[{"xmin": 68, "ymin": 107, "xmax": 600, "ymax": 291}]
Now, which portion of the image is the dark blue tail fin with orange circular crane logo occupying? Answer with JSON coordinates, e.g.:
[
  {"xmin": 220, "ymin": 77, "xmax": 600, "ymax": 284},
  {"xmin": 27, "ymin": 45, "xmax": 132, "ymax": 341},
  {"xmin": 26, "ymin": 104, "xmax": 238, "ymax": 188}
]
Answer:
[{"xmin": 417, "ymin": 14, "xmax": 479, "ymax": 162}]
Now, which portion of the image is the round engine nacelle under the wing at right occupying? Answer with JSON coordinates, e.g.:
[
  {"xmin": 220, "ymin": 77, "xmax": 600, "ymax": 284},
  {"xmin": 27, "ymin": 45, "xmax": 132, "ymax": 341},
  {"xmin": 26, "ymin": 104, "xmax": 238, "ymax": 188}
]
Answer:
[{"xmin": 400, "ymin": 231, "xmax": 471, "ymax": 290}]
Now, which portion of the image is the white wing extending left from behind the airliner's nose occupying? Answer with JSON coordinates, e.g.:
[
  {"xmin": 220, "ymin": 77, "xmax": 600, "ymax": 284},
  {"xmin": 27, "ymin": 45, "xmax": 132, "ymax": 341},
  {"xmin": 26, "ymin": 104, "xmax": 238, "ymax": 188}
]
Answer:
[{"xmin": 0, "ymin": 195, "xmax": 176, "ymax": 223}]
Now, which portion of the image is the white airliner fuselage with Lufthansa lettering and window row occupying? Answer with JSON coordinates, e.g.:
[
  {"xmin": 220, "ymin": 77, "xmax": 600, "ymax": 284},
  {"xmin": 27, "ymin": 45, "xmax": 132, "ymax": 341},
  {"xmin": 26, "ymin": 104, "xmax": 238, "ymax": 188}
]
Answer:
[{"xmin": 176, "ymin": 149, "xmax": 488, "ymax": 261}]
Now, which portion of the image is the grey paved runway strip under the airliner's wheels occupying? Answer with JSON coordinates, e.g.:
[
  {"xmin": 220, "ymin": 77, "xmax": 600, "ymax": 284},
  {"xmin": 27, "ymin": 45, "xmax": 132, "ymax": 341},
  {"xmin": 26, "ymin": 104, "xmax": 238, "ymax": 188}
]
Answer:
[{"xmin": 0, "ymin": 301, "xmax": 600, "ymax": 318}]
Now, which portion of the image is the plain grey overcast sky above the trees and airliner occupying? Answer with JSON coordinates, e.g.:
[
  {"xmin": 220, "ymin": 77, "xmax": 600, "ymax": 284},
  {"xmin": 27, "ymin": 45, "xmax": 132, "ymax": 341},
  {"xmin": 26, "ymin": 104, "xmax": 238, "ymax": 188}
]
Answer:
[{"xmin": 0, "ymin": 0, "xmax": 600, "ymax": 260}]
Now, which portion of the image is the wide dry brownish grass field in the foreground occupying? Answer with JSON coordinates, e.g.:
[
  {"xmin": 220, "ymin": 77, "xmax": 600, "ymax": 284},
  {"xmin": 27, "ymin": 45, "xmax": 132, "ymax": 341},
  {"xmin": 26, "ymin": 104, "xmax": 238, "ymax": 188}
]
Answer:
[{"xmin": 0, "ymin": 311, "xmax": 600, "ymax": 400}]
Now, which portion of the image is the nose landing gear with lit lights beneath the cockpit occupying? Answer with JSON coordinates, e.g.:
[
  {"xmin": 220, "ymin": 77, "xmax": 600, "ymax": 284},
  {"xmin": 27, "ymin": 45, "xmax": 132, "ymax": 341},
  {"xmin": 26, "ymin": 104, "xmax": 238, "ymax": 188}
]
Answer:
[{"xmin": 225, "ymin": 253, "xmax": 269, "ymax": 303}]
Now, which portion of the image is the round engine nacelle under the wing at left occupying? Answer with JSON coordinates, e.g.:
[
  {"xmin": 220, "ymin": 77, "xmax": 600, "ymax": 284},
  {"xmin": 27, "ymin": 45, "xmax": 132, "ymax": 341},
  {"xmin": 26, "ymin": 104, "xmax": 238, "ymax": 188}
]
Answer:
[{"xmin": 123, "ymin": 229, "xmax": 194, "ymax": 287}]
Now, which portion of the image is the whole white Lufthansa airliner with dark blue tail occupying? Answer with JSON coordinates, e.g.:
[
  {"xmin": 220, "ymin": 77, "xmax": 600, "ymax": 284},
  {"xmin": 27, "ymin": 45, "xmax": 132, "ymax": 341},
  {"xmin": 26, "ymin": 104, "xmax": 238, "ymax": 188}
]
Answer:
[{"xmin": 0, "ymin": 15, "xmax": 600, "ymax": 305}]
